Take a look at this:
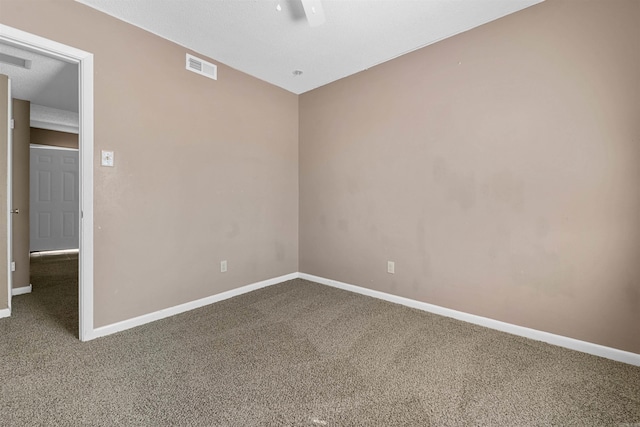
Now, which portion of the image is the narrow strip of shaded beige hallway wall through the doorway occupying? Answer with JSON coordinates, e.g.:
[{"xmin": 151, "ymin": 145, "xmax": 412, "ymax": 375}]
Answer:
[{"xmin": 11, "ymin": 99, "xmax": 31, "ymax": 288}]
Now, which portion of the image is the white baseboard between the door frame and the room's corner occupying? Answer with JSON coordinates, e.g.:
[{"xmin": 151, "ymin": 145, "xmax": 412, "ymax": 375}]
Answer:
[{"xmin": 86, "ymin": 273, "xmax": 299, "ymax": 341}]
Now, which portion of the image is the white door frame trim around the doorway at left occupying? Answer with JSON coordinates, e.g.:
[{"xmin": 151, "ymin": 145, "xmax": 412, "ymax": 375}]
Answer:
[{"xmin": 0, "ymin": 24, "xmax": 95, "ymax": 341}]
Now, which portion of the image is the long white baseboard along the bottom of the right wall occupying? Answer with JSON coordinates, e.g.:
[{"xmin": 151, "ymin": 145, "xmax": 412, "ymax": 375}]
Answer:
[{"xmin": 298, "ymin": 273, "xmax": 640, "ymax": 366}]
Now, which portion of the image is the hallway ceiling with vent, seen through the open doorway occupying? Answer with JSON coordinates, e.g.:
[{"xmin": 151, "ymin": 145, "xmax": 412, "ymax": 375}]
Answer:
[{"xmin": 0, "ymin": 43, "xmax": 78, "ymax": 113}]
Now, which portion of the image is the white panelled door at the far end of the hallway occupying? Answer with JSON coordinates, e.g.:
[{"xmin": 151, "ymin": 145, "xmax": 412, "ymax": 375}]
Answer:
[{"xmin": 29, "ymin": 146, "xmax": 80, "ymax": 252}]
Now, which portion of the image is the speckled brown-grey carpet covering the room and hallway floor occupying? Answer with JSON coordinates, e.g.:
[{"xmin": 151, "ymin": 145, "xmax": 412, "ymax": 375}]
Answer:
[{"xmin": 0, "ymin": 256, "xmax": 640, "ymax": 426}]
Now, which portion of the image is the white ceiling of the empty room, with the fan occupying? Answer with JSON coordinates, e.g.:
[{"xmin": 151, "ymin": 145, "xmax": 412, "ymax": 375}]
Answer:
[{"xmin": 77, "ymin": 0, "xmax": 542, "ymax": 94}]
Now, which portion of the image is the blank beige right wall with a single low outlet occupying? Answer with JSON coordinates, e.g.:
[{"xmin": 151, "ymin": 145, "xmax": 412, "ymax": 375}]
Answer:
[{"xmin": 299, "ymin": 0, "xmax": 640, "ymax": 353}]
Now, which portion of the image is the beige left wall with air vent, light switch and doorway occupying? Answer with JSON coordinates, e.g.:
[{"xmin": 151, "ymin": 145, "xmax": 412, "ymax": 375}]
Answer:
[{"xmin": 0, "ymin": 0, "xmax": 298, "ymax": 327}]
